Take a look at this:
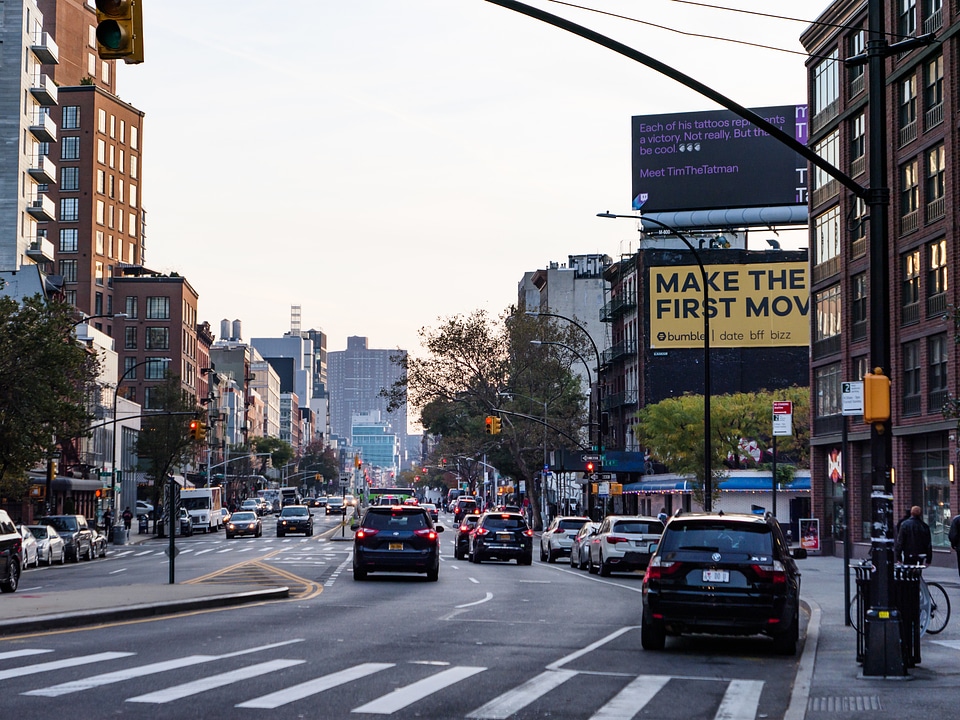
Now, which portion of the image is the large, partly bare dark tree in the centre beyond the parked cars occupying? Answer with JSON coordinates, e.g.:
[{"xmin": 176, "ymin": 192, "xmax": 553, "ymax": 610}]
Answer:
[{"xmin": 385, "ymin": 308, "xmax": 586, "ymax": 521}]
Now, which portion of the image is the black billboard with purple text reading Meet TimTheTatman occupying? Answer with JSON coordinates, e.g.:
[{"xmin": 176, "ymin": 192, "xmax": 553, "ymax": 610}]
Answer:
[{"xmin": 631, "ymin": 105, "xmax": 808, "ymax": 212}]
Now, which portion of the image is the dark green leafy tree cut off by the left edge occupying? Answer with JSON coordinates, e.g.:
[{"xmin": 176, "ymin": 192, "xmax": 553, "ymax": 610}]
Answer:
[{"xmin": 0, "ymin": 295, "xmax": 99, "ymax": 497}]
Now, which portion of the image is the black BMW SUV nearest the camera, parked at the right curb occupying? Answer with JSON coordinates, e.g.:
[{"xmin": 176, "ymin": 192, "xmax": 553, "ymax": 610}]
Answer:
[{"xmin": 640, "ymin": 513, "xmax": 807, "ymax": 655}]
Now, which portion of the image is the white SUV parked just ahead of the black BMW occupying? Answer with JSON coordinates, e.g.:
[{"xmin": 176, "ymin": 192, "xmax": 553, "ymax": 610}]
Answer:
[{"xmin": 587, "ymin": 515, "xmax": 663, "ymax": 577}]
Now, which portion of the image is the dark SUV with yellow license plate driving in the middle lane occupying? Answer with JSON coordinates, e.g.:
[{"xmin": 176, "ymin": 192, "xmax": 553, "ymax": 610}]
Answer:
[{"xmin": 353, "ymin": 505, "xmax": 443, "ymax": 581}]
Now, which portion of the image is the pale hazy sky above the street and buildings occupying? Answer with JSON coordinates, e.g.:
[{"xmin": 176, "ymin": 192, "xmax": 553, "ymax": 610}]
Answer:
[{"xmin": 117, "ymin": 0, "xmax": 828, "ymax": 353}]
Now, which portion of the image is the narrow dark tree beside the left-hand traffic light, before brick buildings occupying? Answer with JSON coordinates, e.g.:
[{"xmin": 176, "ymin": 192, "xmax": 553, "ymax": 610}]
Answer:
[{"xmin": 136, "ymin": 373, "xmax": 203, "ymax": 507}]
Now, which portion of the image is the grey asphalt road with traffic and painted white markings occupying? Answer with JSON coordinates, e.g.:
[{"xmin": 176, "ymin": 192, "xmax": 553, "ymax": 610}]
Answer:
[{"xmin": 0, "ymin": 516, "xmax": 797, "ymax": 720}]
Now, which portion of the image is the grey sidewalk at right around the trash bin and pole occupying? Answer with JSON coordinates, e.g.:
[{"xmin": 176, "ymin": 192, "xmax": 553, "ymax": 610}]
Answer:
[{"xmin": 786, "ymin": 556, "xmax": 960, "ymax": 720}]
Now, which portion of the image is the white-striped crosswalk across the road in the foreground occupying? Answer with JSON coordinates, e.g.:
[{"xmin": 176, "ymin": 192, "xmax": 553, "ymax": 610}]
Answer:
[{"xmin": 0, "ymin": 638, "xmax": 764, "ymax": 720}]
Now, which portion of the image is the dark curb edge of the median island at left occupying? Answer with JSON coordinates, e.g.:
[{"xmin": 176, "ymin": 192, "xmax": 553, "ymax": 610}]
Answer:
[{"xmin": 0, "ymin": 587, "xmax": 290, "ymax": 636}]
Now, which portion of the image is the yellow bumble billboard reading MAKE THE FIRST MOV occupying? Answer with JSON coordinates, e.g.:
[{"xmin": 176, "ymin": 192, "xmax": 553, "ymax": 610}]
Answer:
[{"xmin": 647, "ymin": 262, "xmax": 810, "ymax": 350}]
